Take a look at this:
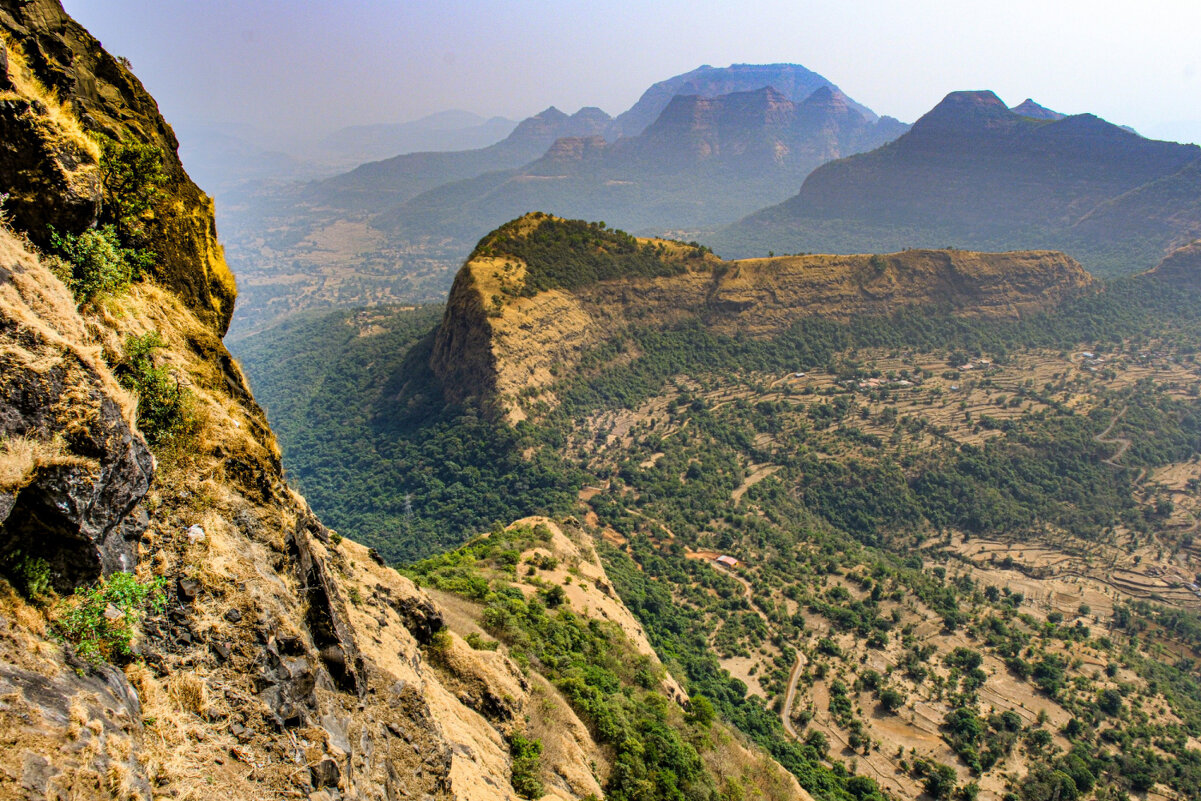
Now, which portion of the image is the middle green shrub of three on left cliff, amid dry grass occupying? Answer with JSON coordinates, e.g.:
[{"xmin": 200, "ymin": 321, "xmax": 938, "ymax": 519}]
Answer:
[{"xmin": 115, "ymin": 331, "xmax": 198, "ymax": 448}]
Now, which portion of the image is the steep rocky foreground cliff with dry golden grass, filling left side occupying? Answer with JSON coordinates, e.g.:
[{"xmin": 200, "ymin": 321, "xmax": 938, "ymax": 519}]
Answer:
[{"xmin": 0, "ymin": 0, "xmax": 763, "ymax": 801}]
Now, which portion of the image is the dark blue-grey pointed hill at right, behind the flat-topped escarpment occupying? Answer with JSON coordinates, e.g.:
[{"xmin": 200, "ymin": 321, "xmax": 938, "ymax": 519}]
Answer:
[{"xmin": 710, "ymin": 91, "xmax": 1201, "ymax": 274}]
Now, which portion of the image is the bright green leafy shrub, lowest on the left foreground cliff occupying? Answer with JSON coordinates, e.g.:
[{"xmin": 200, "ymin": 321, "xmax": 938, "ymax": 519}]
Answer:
[{"xmin": 55, "ymin": 573, "xmax": 167, "ymax": 664}]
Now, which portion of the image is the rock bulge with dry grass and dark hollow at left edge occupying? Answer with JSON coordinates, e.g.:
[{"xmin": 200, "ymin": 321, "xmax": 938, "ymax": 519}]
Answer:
[{"xmin": 0, "ymin": 232, "xmax": 154, "ymax": 592}]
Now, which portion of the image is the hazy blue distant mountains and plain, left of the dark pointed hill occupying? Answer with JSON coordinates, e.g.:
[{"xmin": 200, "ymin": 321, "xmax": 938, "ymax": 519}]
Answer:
[{"xmin": 221, "ymin": 65, "xmax": 906, "ymax": 336}]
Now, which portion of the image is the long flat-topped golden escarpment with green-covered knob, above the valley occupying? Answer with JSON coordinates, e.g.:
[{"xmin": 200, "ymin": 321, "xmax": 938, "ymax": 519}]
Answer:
[{"xmin": 431, "ymin": 214, "xmax": 1094, "ymax": 422}]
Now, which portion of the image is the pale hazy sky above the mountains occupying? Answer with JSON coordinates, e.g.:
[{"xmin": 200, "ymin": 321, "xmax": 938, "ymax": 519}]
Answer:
[{"xmin": 64, "ymin": 0, "xmax": 1201, "ymax": 148}]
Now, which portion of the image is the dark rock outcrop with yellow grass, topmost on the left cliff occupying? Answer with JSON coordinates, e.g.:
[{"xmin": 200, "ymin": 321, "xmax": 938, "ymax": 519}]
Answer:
[{"xmin": 0, "ymin": 0, "xmax": 237, "ymax": 333}]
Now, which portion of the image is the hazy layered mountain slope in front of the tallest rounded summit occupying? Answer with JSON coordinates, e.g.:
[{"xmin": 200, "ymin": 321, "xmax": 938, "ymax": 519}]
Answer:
[{"xmin": 375, "ymin": 85, "xmax": 906, "ymax": 241}]
